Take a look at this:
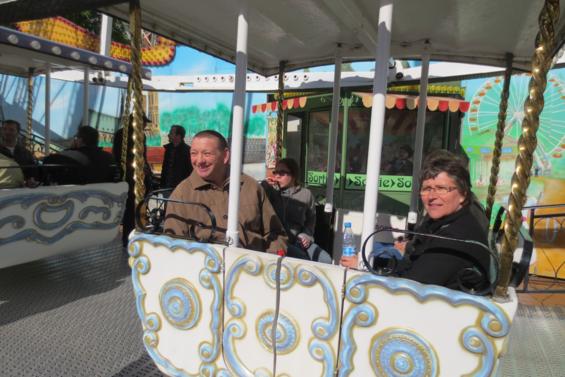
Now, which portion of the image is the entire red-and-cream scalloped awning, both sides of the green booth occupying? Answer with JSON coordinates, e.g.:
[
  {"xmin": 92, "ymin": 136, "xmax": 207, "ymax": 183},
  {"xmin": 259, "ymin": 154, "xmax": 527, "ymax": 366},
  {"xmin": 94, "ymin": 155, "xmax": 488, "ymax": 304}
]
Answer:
[{"xmin": 251, "ymin": 92, "xmax": 470, "ymax": 114}]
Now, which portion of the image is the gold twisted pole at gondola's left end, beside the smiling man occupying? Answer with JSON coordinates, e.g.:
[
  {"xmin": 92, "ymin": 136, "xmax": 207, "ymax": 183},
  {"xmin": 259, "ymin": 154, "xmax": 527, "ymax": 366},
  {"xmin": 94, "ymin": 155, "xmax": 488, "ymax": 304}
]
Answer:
[{"xmin": 128, "ymin": 0, "xmax": 145, "ymax": 208}]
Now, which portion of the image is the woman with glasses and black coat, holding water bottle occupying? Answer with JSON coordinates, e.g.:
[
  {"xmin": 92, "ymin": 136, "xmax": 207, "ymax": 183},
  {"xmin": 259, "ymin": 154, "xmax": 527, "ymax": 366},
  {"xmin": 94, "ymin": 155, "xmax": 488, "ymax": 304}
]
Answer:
[{"xmin": 341, "ymin": 153, "xmax": 490, "ymax": 290}]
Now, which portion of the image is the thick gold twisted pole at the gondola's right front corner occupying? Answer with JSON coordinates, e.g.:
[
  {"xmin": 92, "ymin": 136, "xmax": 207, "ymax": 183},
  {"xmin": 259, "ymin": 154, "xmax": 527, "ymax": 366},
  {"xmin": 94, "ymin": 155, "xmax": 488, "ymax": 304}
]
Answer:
[{"xmin": 495, "ymin": 0, "xmax": 559, "ymax": 299}]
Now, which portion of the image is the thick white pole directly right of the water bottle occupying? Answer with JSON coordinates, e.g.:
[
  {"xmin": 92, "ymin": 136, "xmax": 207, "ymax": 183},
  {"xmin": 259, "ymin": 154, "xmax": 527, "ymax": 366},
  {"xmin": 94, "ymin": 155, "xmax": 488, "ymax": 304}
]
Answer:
[{"xmin": 361, "ymin": 0, "xmax": 393, "ymax": 251}]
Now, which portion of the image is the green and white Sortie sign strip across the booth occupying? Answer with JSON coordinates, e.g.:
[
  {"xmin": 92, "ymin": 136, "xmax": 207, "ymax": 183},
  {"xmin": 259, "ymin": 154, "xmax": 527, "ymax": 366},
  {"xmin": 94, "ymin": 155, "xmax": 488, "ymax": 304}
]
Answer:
[{"xmin": 307, "ymin": 171, "xmax": 412, "ymax": 192}]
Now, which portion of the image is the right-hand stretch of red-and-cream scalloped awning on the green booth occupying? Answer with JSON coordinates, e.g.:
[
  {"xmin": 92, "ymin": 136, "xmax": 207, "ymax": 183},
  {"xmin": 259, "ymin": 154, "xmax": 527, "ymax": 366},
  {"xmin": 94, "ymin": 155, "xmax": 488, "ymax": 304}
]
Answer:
[{"xmin": 353, "ymin": 92, "xmax": 470, "ymax": 113}]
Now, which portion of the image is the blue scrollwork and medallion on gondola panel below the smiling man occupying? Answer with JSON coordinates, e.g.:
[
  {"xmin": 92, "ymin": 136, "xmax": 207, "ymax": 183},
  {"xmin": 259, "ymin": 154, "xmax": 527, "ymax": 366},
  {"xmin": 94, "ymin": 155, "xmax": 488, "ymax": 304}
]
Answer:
[{"xmin": 128, "ymin": 233, "xmax": 222, "ymax": 377}]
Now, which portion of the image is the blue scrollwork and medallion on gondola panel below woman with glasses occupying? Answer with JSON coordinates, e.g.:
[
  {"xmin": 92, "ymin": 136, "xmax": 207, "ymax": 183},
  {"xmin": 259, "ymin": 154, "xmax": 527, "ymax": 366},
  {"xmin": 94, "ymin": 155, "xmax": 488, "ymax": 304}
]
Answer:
[{"xmin": 339, "ymin": 274, "xmax": 510, "ymax": 376}]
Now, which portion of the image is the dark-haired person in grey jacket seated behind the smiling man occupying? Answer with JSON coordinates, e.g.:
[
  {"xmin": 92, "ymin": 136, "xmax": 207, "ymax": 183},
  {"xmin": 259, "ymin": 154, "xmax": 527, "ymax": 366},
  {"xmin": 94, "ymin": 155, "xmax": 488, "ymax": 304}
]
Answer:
[{"xmin": 262, "ymin": 158, "xmax": 332, "ymax": 263}]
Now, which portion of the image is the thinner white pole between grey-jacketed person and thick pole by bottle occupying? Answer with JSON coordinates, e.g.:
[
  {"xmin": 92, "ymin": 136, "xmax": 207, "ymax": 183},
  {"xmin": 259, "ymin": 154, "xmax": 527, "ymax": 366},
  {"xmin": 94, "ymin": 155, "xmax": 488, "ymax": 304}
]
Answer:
[{"xmin": 324, "ymin": 45, "xmax": 347, "ymax": 213}]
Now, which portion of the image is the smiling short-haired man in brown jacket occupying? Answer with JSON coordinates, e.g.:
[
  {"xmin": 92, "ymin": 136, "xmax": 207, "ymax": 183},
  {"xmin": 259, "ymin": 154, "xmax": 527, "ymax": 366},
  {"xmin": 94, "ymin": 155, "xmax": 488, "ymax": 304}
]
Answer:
[{"xmin": 164, "ymin": 130, "xmax": 287, "ymax": 253}]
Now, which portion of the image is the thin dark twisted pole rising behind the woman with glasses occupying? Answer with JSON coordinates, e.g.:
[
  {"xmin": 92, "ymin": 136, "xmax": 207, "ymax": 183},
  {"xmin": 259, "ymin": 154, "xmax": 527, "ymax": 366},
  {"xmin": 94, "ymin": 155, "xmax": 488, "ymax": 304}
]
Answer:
[{"xmin": 486, "ymin": 53, "xmax": 513, "ymax": 220}]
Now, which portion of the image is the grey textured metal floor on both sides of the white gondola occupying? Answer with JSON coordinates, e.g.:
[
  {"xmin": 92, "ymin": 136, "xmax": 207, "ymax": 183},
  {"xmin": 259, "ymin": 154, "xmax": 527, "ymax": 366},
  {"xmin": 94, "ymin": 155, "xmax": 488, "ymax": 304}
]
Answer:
[{"xmin": 0, "ymin": 238, "xmax": 565, "ymax": 377}]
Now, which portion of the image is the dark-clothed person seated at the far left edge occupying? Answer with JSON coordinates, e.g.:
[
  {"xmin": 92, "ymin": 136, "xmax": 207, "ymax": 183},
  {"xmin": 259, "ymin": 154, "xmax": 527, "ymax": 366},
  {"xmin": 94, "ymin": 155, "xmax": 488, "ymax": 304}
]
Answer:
[{"xmin": 0, "ymin": 119, "xmax": 38, "ymax": 184}]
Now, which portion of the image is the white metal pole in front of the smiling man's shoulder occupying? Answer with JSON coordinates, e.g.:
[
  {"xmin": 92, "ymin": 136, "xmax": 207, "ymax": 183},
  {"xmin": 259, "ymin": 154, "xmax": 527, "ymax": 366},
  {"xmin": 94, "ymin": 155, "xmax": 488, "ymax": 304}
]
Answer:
[{"xmin": 226, "ymin": 5, "xmax": 248, "ymax": 246}]
